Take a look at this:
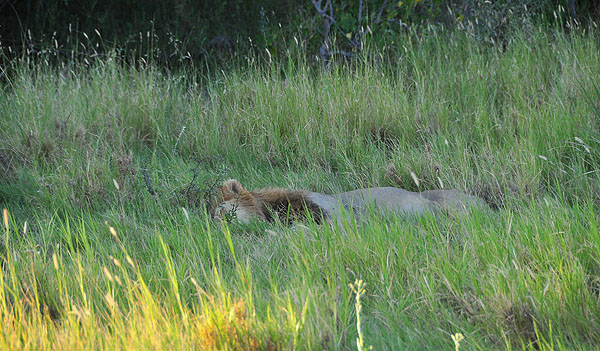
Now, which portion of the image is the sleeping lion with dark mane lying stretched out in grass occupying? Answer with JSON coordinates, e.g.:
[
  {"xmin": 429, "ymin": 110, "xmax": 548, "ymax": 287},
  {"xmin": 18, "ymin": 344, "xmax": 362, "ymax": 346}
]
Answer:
[{"xmin": 211, "ymin": 179, "xmax": 487, "ymax": 223}]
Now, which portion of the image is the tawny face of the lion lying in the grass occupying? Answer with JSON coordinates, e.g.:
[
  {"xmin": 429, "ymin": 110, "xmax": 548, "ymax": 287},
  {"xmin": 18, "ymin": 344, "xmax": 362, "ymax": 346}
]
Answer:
[{"xmin": 212, "ymin": 179, "xmax": 266, "ymax": 223}]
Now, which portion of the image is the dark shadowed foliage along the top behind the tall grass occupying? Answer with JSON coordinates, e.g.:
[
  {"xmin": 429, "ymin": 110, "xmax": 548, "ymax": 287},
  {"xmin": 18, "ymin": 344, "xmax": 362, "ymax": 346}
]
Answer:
[{"xmin": 0, "ymin": 0, "xmax": 600, "ymax": 63}]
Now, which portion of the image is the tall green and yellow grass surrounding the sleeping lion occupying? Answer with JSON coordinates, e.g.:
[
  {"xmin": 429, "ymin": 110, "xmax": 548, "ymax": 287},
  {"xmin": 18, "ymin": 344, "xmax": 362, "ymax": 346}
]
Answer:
[{"xmin": 0, "ymin": 30, "xmax": 600, "ymax": 350}]
